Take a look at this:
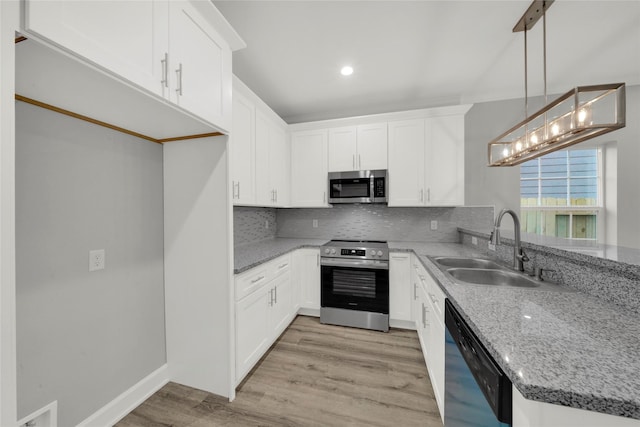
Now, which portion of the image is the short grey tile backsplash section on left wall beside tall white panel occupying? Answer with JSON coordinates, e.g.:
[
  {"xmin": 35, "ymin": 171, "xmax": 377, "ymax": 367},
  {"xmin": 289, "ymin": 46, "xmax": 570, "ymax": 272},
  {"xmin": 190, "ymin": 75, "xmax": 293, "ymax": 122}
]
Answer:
[{"xmin": 233, "ymin": 206, "xmax": 277, "ymax": 245}]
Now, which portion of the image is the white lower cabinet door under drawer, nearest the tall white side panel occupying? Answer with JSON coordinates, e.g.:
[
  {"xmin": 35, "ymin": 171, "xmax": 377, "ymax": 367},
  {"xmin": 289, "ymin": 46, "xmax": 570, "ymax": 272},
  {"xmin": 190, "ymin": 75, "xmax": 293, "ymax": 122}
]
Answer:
[{"xmin": 236, "ymin": 285, "xmax": 272, "ymax": 382}]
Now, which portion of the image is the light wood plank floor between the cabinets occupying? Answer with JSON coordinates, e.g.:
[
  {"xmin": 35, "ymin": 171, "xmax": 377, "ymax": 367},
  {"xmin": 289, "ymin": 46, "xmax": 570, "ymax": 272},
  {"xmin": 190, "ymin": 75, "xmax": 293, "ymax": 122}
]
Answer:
[{"xmin": 116, "ymin": 316, "xmax": 442, "ymax": 427}]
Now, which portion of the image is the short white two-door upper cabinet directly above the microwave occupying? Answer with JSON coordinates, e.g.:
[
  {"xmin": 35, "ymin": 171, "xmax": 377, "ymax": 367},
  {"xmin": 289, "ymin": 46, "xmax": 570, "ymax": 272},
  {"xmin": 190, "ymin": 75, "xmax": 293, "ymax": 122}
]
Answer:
[{"xmin": 329, "ymin": 123, "xmax": 387, "ymax": 172}]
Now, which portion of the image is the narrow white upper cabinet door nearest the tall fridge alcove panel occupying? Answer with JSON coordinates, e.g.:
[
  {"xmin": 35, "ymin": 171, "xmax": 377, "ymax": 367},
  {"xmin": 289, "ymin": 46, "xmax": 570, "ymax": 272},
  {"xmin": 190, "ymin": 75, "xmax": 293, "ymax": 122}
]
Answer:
[{"xmin": 229, "ymin": 93, "xmax": 256, "ymax": 205}]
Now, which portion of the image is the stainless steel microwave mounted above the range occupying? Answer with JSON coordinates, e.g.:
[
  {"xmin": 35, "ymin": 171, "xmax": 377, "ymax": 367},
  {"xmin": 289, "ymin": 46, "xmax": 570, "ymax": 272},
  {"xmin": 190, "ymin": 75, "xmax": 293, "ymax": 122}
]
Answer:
[{"xmin": 329, "ymin": 170, "xmax": 388, "ymax": 203}]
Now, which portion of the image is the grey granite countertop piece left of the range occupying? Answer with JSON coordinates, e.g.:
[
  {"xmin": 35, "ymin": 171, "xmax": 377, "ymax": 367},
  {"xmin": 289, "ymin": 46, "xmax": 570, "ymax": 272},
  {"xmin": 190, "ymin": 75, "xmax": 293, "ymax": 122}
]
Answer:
[{"xmin": 233, "ymin": 238, "xmax": 328, "ymax": 274}]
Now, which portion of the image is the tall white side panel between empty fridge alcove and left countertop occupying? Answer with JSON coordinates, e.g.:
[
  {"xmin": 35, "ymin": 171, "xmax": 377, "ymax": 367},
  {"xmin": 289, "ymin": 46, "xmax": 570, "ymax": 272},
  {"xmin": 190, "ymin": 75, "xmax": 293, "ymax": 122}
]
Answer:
[{"xmin": 164, "ymin": 136, "xmax": 233, "ymax": 396}]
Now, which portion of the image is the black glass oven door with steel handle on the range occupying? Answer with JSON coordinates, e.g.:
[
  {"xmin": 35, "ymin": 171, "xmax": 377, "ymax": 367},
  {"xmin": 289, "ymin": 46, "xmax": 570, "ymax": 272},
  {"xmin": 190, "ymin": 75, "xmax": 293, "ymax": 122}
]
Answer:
[{"xmin": 320, "ymin": 258, "xmax": 389, "ymax": 314}]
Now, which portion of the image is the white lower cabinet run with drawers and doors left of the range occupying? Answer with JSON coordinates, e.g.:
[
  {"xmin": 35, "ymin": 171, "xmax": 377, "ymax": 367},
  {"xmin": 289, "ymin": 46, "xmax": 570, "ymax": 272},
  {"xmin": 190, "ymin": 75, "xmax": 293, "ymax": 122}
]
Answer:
[{"xmin": 235, "ymin": 254, "xmax": 296, "ymax": 385}]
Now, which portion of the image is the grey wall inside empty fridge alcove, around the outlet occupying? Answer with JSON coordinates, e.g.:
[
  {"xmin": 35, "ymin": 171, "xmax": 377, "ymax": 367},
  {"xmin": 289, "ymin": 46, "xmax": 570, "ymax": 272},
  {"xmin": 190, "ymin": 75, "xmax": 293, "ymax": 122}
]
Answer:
[{"xmin": 16, "ymin": 102, "xmax": 166, "ymax": 426}]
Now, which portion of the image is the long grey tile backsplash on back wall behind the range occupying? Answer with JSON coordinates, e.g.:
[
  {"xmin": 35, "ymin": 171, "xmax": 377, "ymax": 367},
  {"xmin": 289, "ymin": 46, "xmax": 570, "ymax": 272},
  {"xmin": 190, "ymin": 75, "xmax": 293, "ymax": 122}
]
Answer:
[{"xmin": 277, "ymin": 204, "xmax": 493, "ymax": 242}]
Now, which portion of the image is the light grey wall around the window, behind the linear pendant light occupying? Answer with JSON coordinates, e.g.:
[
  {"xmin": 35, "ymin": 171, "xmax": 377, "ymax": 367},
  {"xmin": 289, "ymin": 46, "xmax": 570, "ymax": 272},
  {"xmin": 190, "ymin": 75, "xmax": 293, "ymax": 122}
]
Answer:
[{"xmin": 465, "ymin": 86, "xmax": 640, "ymax": 248}]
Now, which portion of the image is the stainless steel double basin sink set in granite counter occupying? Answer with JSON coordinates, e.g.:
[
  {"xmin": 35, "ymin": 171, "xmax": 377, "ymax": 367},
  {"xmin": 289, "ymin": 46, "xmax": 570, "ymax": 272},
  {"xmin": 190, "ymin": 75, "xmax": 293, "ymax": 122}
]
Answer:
[{"xmin": 428, "ymin": 256, "xmax": 571, "ymax": 292}]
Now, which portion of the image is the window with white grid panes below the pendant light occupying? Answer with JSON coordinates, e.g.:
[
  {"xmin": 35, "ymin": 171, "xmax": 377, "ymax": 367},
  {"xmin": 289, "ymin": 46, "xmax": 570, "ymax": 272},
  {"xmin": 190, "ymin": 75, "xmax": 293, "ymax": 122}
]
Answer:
[{"xmin": 520, "ymin": 149, "xmax": 604, "ymax": 240}]
